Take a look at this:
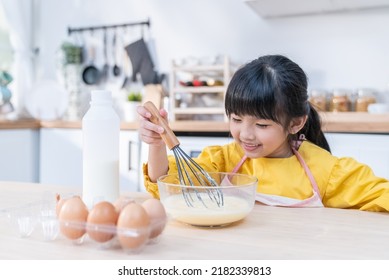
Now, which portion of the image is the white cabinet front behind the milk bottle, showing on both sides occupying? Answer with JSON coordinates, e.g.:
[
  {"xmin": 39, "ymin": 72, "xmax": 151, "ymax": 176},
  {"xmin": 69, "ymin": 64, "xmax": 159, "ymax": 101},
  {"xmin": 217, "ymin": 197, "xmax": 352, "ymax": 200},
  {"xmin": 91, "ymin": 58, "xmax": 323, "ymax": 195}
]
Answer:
[{"xmin": 39, "ymin": 128, "xmax": 140, "ymax": 191}]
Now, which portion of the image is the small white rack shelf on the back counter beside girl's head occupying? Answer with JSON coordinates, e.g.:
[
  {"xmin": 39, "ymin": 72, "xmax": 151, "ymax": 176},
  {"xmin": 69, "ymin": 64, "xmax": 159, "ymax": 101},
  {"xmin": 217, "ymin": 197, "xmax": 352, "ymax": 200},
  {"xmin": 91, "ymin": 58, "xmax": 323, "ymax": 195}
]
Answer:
[{"xmin": 169, "ymin": 56, "xmax": 234, "ymax": 121}]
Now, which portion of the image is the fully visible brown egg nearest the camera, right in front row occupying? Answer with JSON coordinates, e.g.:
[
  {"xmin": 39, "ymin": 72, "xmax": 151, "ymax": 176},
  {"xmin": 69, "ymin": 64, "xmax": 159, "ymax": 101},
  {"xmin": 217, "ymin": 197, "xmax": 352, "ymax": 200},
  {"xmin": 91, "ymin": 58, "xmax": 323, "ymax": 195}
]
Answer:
[{"xmin": 117, "ymin": 202, "xmax": 150, "ymax": 251}]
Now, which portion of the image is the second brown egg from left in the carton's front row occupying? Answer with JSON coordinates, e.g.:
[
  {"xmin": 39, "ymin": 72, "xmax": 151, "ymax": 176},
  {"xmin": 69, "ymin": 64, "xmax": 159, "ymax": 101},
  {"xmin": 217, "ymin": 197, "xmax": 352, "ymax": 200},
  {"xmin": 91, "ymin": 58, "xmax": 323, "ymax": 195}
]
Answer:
[{"xmin": 86, "ymin": 201, "xmax": 119, "ymax": 242}]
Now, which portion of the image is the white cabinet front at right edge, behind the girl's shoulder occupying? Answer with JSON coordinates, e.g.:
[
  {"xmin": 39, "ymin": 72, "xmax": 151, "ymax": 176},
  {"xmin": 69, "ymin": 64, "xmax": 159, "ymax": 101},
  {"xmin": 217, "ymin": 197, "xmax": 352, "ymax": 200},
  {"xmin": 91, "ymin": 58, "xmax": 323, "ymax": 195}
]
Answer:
[{"xmin": 325, "ymin": 133, "xmax": 389, "ymax": 179}]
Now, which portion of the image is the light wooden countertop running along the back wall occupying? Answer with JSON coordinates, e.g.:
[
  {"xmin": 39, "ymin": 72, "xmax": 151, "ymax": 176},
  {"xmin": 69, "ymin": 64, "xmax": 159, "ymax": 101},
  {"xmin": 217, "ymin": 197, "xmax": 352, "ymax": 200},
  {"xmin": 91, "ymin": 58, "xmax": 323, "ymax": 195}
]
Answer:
[{"xmin": 0, "ymin": 112, "xmax": 389, "ymax": 134}]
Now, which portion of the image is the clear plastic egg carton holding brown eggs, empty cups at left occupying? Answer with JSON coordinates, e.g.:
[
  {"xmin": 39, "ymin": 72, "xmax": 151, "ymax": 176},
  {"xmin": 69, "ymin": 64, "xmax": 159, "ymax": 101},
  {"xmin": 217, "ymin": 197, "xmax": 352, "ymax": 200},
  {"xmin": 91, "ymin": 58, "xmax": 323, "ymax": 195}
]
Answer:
[{"xmin": 0, "ymin": 199, "xmax": 167, "ymax": 254}]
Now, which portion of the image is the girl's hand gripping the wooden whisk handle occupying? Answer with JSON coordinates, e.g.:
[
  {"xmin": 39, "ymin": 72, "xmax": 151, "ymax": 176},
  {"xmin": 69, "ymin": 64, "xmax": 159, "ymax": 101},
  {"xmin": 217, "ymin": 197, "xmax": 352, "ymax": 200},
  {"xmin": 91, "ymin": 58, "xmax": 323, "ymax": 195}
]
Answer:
[{"xmin": 137, "ymin": 106, "xmax": 167, "ymax": 146}]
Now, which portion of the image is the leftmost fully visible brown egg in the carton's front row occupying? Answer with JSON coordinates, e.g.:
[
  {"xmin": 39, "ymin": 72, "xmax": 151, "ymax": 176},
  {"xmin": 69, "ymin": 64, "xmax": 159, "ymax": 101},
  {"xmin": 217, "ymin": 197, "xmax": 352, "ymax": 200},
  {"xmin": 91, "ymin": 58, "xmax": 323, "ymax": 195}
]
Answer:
[{"xmin": 58, "ymin": 196, "xmax": 88, "ymax": 240}]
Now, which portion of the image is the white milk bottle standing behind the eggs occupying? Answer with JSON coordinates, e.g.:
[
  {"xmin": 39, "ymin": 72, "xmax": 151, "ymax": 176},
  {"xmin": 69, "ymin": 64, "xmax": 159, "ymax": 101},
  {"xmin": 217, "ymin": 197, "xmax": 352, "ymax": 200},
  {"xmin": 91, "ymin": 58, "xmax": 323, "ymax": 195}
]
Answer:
[{"xmin": 82, "ymin": 90, "xmax": 120, "ymax": 208}]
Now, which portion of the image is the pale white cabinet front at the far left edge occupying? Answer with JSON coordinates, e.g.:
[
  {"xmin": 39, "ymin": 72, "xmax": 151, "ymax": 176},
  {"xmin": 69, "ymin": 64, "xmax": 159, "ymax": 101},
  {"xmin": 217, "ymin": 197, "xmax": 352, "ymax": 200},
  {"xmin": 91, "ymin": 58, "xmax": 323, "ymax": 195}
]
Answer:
[{"xmin": 0, "ymin": 129, "xmax": 39, "ymax": 183}]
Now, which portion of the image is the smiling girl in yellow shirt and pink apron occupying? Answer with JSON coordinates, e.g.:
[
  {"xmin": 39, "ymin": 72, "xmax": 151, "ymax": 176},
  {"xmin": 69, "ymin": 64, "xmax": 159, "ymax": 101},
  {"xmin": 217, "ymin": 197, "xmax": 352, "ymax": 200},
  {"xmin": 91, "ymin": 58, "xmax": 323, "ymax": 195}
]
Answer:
[{"xmin": 138, "ymin": 55, "xmax": 389, "ymax": 211}]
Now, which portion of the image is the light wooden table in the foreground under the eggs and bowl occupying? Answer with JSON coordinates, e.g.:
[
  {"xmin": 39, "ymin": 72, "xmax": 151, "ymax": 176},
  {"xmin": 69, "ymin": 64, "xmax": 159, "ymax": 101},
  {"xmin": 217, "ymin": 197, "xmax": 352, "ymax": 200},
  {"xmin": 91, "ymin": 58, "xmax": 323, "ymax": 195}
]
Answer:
[{"xmin": 0, "ymin": 182, "xmax": 389, "ymax": 260}]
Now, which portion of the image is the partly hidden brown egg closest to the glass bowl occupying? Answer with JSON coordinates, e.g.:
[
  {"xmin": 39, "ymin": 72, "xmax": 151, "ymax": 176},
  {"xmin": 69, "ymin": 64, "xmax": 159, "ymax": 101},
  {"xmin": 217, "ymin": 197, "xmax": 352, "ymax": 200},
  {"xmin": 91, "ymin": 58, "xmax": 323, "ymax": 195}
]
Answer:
[{"xmin": 142, "ymin": 198, "xmax": 167, "ymax": 238}]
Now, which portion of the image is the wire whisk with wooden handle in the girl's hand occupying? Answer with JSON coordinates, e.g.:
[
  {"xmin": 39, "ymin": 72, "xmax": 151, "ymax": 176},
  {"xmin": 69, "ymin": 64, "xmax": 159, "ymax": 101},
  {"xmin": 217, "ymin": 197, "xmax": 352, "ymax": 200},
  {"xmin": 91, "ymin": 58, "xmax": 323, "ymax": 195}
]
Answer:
[{"xmin": 144, "ymin": 101, "xmax": 224, "ymax": 207}]
